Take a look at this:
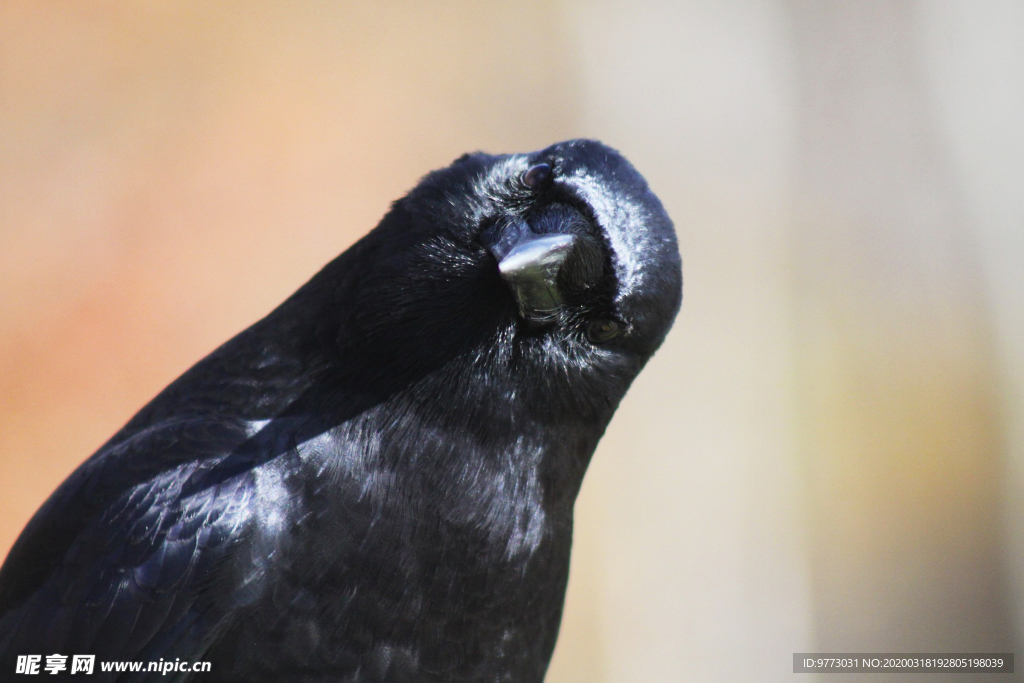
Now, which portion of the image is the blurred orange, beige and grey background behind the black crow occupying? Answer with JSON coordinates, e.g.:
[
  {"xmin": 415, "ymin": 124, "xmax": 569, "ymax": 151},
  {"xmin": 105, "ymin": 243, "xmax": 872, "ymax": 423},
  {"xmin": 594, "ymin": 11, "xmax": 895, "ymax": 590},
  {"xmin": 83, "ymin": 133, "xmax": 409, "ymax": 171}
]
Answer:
[{"xmin": 0, "ymin": 0, "xmax": 1024, "ymax": 683}]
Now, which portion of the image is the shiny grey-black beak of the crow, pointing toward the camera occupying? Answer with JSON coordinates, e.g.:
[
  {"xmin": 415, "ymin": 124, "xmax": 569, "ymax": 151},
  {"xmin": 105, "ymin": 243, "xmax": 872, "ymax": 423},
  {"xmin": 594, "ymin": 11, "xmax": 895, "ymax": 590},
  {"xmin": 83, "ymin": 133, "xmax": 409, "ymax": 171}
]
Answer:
[{"xmin": 496, "ymin": 229, "xmax": 577, "ymax": 323}]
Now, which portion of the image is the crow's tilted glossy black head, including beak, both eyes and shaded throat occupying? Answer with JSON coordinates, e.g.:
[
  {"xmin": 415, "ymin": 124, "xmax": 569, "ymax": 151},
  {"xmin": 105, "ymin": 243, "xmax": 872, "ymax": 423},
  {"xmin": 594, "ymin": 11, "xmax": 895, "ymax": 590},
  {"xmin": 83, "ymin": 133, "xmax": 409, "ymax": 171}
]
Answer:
[{"xmin": 310, "ymin": 140, "xmax": 682, "ymax": 417}]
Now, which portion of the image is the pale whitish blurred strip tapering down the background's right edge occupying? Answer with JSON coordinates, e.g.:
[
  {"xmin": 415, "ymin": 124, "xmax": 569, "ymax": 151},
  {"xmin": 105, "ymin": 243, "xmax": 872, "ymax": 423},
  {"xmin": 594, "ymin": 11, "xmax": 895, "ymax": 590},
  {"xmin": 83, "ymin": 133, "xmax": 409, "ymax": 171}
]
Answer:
[{"xmin": 920, "ymin": 0, "xmax": 1024, "ymax": 663}]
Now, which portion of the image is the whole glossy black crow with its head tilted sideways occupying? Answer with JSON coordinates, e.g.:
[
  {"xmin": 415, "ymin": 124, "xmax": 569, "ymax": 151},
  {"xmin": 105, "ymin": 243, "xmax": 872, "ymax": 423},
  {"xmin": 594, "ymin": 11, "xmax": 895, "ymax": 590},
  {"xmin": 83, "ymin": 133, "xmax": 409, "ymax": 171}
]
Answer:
[{"xmin": 0, "ymin": 140, "xmax": 682, "ymax": 683}]
